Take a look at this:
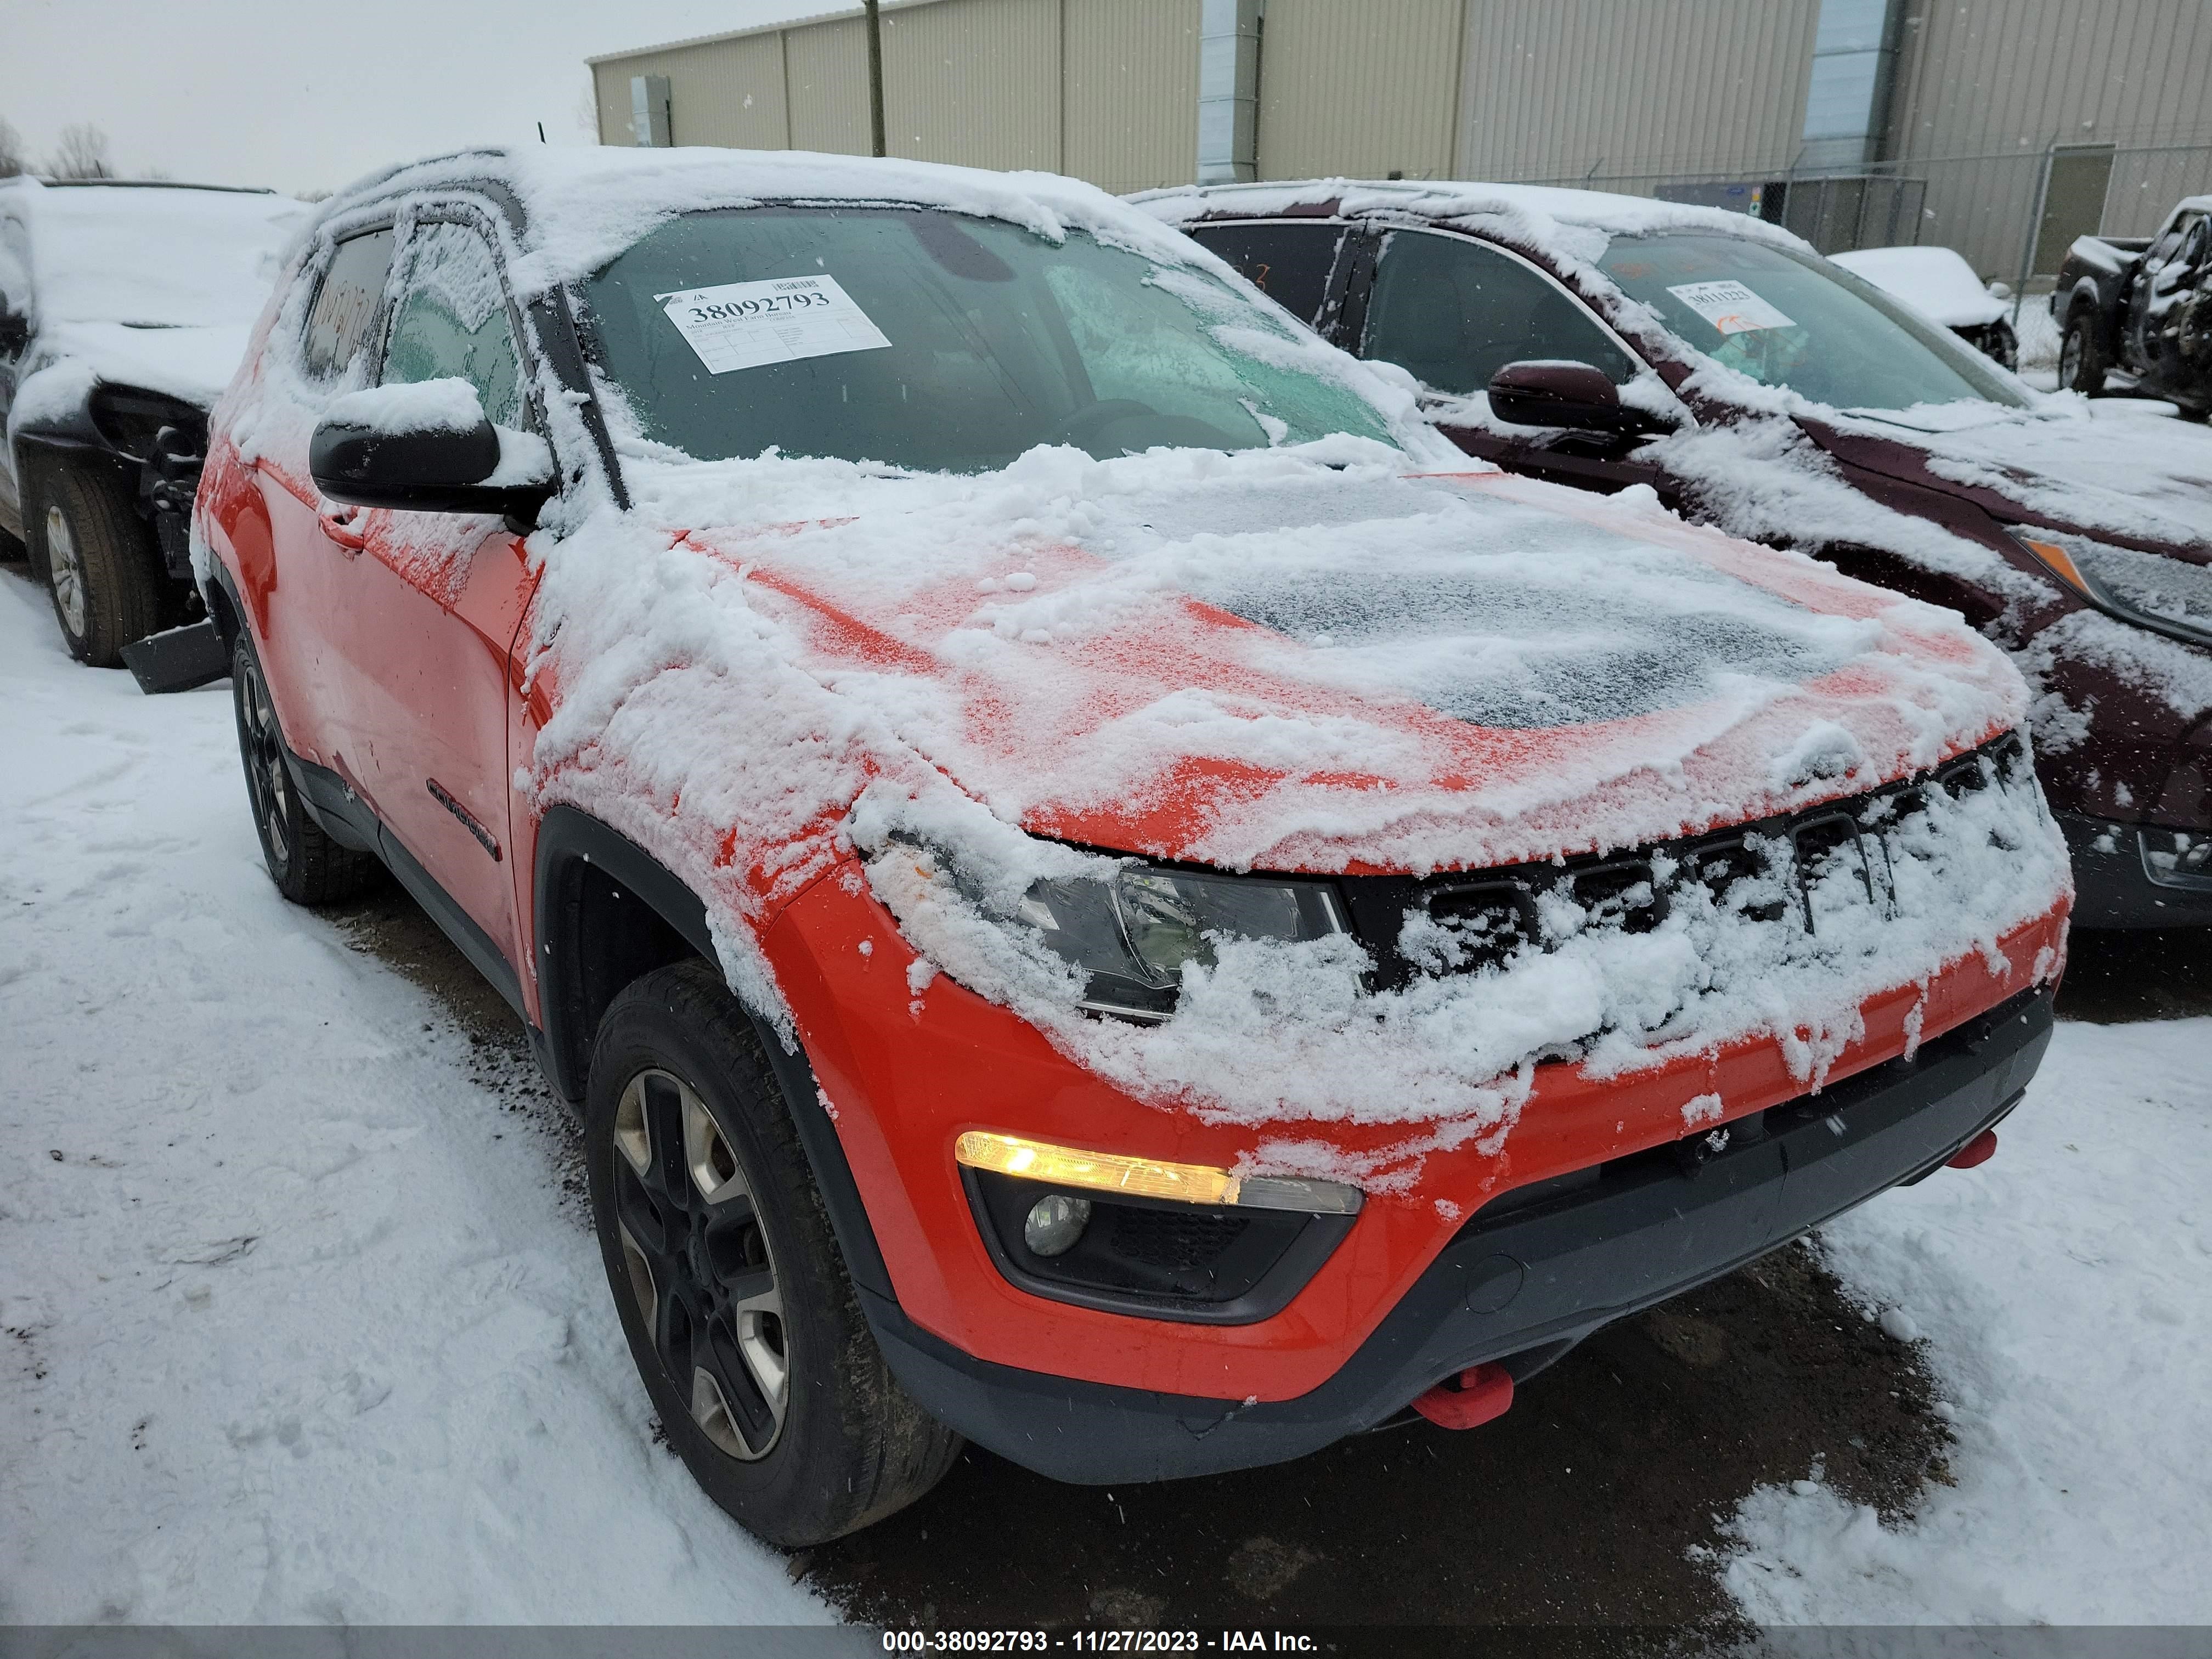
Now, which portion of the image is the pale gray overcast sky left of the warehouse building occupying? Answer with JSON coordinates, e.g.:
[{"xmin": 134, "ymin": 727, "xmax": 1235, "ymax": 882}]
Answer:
[{"xmin": 0, "ymin": 0, "xmax": 818, "ymax": 190}]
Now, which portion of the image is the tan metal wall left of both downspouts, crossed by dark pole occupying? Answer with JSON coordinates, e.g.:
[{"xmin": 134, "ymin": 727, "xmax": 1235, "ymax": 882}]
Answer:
[{"xmin": 593, "ymin": 0, "xmax": 1199, "ymax": 190}]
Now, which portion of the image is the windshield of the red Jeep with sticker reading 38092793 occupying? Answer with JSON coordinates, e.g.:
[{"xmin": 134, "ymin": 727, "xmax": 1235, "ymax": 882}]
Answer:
[{"xmin": 586, "ymin": 208, "xmax": 1389, "ymax": 473}]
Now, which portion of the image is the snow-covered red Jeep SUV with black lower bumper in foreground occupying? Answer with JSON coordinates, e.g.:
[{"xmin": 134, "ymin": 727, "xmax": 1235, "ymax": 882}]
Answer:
[{"xmin": 195, "ymin": 150, "xmax": 2070, "ymax": 1544}]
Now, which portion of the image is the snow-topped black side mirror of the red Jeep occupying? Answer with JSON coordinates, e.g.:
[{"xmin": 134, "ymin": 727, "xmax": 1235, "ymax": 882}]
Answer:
[{"xmin": 307, "ymin": 381, "xmax": 553, "ymax": 522}]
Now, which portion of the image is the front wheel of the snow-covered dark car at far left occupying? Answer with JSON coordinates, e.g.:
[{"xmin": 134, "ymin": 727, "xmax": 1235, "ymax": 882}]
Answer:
[{"xmin": 22, "ymin": 460, "xmax": 168, "ymax": 668}]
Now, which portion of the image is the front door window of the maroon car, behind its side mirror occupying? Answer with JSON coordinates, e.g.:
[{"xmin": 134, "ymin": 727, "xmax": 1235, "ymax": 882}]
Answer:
[{"xmin": 1361, "ymin": 230, "xmax": 1637, "ymax": 396}]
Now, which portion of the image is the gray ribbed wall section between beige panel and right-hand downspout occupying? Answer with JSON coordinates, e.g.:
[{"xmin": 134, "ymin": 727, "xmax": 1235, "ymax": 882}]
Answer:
[{"xmin": 1451, "ymin": 0, "xmax": 1820, "ymax": 193}]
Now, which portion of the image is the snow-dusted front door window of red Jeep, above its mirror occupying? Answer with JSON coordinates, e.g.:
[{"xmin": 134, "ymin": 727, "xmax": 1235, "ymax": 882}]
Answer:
[{"xmin": 385, "ymin": 223, "xmax": 524, "ymax": 429}]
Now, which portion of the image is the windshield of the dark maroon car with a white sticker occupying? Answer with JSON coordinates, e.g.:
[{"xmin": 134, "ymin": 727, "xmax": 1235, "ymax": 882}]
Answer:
[{"xmin": 1597, "ymin": 232, "xmax": 2026, "ymax": 409}]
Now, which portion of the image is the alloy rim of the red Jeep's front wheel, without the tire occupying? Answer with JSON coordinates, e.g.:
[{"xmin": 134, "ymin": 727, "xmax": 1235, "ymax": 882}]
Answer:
[{"xmin": 613, "ymin": 1068, "xmax": 789, "ymax": 1462}]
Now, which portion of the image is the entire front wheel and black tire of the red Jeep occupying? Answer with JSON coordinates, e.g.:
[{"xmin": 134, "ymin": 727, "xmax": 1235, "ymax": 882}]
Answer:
[{"xmin": 584, "ymin": 962, "xmax": 962, "ymax": 1548}]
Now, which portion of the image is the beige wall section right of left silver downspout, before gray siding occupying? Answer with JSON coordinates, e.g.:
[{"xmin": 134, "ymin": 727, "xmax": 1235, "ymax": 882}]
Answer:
[{"xmin": 1259, "ymin": 0, "xmax": 1469, "ymax": 179}]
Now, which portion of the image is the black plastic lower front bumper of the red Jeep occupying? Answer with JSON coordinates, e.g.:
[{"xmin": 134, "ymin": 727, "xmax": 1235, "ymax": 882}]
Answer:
[{"xmin": 862, "ymin": 989, "xmax": 2051, "ymax": 1484}]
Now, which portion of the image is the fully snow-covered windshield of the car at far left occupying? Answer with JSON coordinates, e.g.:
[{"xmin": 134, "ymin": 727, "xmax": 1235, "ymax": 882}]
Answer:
[{"xmin": 31, "ymin": 186, "xmax": 307, "ymax": 328}]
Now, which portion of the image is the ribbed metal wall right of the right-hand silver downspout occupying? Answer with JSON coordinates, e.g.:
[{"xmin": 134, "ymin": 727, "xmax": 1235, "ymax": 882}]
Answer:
[{"xmin": 1884, "ymin": 0, "xmax": 2212, "ymax": 279}]
